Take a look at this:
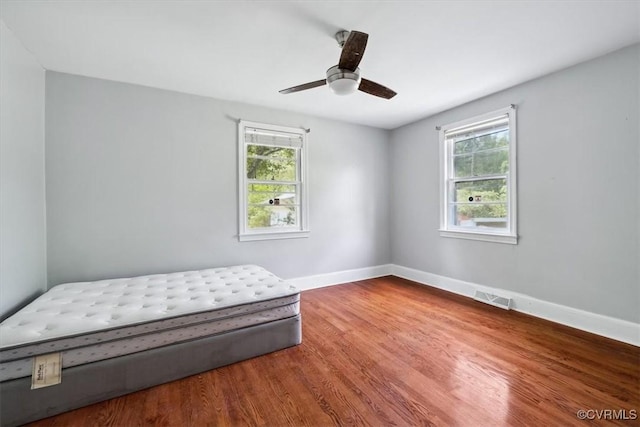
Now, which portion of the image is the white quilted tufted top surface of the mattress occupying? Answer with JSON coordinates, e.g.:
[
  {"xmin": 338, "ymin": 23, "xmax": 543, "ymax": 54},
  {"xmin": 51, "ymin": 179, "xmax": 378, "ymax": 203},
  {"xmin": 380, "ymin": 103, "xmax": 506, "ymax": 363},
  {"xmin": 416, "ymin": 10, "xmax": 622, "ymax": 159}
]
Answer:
[{"xmin": 0, "ymin": 265, "xmax": 299, "ymax": 349}]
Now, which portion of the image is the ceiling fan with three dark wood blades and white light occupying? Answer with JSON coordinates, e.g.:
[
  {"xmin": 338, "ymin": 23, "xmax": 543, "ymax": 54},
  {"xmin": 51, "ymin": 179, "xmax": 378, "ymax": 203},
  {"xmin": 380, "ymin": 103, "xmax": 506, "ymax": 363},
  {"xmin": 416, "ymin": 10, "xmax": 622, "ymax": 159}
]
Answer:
[{"xmin": 280, "ymin": 30, "xmax": 396, "ymax": 99}]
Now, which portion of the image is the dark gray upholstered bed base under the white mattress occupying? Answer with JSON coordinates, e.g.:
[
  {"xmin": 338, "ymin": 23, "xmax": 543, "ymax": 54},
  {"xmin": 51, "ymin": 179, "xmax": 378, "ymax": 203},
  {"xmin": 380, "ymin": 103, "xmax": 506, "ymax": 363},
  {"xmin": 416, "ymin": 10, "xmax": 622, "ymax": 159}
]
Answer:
[{"xmin": 0, "ymin": 315, "xmax": 302, "ymax": 427}]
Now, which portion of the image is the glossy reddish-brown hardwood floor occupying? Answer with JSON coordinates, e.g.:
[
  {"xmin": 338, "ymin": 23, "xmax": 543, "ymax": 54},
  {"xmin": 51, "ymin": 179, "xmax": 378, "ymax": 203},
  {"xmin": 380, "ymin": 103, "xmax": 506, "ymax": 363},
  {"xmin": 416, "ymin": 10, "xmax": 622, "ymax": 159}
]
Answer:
[{"xmin": 26, "ymin": 277, "xmax": 640, "ymax": 426}]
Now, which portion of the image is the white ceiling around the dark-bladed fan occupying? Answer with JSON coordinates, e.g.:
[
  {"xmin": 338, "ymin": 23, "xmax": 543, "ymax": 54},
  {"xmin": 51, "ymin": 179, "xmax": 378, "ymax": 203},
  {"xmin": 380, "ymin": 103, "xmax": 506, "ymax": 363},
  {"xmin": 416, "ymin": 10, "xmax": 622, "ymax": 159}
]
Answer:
[{"xmin": 0, "ymin": 0, "xmax": 640, "ymax": 129}]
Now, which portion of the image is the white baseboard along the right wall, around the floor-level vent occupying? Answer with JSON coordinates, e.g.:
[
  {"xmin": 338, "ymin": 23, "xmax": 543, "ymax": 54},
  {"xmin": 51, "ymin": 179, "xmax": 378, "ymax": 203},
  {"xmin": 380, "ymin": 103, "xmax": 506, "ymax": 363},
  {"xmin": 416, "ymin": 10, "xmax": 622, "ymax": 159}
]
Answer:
[{"xmin": 391, "ymin": 265, "xmax": 640, "ymax": 347}]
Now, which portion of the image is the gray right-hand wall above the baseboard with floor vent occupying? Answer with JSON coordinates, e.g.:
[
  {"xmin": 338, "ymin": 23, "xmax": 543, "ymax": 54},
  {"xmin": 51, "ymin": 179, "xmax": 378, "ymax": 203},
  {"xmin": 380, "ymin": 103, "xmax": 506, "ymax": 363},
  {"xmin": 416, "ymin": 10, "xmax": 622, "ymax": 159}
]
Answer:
[{"xmin": 390, "ymin": 45, "xmax": 640, "ymax": 323}]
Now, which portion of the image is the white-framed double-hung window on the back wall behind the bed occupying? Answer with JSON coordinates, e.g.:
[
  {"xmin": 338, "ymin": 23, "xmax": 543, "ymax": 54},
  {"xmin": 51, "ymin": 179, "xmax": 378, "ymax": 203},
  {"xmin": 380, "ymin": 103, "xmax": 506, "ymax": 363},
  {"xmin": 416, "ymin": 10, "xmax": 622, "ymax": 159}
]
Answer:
[{"xmin": 238, "ymin": 120, "xmax": 309, "ymax": 241}]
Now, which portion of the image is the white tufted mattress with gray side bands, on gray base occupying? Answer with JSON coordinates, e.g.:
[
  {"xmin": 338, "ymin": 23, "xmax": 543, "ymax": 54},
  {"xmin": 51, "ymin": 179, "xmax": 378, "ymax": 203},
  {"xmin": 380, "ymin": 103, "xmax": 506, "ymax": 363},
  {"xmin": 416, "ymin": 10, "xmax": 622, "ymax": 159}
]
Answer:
[{"xmin": 0, "ymin": 265, "xmax": 299, "ymax": 381}]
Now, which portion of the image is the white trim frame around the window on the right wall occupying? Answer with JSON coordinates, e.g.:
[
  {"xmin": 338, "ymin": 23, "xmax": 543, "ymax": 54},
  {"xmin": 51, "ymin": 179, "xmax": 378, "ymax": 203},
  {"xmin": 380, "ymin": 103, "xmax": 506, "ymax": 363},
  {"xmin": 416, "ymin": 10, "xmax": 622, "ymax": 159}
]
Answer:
[{"xmin": 438, "ymin": 105, "xmax": 518, "ymax": 245}]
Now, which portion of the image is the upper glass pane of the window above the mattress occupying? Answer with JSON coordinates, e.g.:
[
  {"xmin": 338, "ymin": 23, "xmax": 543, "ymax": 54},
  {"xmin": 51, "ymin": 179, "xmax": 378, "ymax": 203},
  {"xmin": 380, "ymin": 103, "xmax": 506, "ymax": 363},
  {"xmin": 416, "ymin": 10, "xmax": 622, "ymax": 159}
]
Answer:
[{"xmin": 247, "ymin": 144, "xmax": 298, "ymax": 181}]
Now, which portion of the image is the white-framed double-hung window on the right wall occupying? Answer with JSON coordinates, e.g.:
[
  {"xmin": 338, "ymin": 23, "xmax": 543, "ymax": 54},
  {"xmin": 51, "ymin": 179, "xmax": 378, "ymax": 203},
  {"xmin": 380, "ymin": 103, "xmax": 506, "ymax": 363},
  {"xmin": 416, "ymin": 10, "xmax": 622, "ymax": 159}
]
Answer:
[{"xmin": 439, "ymin": 106, "xmax": 517, "ymax": 244}]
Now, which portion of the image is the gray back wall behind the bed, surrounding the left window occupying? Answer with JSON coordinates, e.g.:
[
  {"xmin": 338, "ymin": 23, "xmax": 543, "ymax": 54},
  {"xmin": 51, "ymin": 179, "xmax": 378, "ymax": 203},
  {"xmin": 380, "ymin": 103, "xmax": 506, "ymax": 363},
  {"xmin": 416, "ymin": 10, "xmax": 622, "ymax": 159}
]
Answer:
[{"xmin": 46, "ymin": 71, "xmax": 390, "ymax": 285}]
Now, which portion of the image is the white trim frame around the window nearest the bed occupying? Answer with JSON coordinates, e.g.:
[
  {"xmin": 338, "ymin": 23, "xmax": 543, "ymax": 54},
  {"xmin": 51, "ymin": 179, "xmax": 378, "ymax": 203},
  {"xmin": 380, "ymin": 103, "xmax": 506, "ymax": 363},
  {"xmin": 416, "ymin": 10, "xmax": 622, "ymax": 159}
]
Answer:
[{"xmin": 238, "ymin": 120, "xmax": 310, "ymax": 242}]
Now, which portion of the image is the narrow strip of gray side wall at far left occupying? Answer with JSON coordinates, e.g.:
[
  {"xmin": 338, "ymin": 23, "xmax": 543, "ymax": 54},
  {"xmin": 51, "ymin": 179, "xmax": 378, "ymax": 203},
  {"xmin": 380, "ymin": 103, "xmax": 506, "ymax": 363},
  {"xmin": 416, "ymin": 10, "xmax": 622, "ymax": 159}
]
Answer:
[{"xmin": 0, "ymin": 21, "xmax": 46, "ymax": 318}]
